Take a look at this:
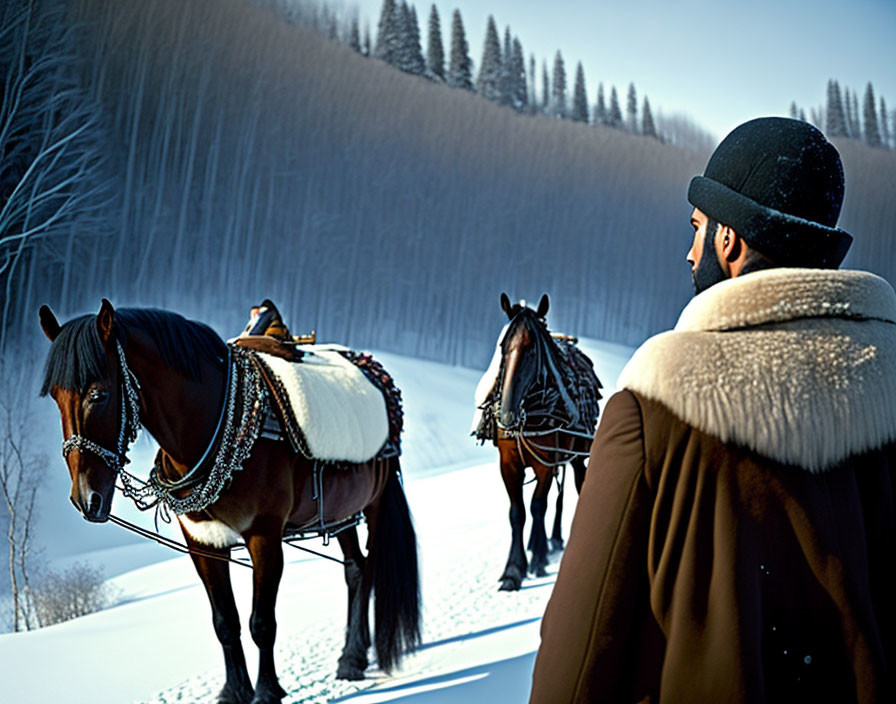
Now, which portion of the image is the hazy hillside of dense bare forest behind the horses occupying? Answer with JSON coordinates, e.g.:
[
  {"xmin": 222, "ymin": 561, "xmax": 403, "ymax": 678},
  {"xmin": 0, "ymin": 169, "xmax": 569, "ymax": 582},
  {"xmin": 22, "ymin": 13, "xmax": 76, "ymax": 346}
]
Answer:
[{"xmin": 0, "ymin": 0, "xmax": 896, "ymax": 366}]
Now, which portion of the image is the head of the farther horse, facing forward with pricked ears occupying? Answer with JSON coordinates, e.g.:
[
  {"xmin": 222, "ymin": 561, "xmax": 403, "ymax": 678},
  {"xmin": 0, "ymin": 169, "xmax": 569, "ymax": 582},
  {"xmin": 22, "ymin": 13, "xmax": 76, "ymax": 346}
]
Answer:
[{"xmin": 498, "ymin": 293, "xmax": 550, "ymax": 429}]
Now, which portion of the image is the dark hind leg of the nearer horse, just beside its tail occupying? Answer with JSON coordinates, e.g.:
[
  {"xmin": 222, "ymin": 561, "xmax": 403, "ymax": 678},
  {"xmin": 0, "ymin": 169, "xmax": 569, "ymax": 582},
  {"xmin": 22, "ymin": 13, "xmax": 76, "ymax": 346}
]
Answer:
[{"xmin": 336, "ymin": 528, "xmax": 370, "ymax": 680}]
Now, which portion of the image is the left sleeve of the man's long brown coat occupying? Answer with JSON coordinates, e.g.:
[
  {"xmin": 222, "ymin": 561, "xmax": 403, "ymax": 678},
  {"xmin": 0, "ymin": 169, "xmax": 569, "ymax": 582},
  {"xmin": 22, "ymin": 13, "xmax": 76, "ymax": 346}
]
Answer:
[{"xmin": 530, "ymin": 391, "xmax": 663, "ymax": 704}]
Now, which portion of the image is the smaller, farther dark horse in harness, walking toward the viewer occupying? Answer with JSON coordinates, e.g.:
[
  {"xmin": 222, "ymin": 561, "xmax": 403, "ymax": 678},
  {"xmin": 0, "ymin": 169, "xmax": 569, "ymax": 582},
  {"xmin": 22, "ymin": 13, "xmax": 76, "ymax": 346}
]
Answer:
[{"xmin": 477, "ymin": 293, "xmax": 601, "ymax": 591}]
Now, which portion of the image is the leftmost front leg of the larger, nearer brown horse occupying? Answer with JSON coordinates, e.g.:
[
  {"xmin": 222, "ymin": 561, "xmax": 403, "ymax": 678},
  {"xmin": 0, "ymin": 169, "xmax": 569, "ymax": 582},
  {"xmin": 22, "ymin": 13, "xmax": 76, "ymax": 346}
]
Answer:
[{"xmin": 184, "ymin": 531, "xmax": 253, "ymax": 704}]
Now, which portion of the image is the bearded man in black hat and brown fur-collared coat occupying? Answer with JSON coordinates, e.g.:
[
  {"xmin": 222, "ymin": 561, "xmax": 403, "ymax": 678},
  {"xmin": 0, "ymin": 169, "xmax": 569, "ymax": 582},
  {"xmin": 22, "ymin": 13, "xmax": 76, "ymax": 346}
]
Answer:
[{"xmin": 531, "ymin": 118, "xmax": 896, "ymax": 704}]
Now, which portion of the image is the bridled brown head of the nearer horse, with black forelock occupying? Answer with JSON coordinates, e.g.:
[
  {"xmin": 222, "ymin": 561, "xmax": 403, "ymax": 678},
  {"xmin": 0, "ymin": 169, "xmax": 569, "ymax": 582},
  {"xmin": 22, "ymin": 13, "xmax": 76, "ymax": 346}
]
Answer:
[{"xmin": 40, "ymin": 299, "xmax": 126, "ymax": 522}]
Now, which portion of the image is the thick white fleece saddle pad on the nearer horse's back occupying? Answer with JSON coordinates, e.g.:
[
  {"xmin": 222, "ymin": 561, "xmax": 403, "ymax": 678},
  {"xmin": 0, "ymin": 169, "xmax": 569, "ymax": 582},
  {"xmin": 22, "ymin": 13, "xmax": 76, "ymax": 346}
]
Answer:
[{"xmin": 258, "ymin": 345, "xmax": 389, "ymax": 462}]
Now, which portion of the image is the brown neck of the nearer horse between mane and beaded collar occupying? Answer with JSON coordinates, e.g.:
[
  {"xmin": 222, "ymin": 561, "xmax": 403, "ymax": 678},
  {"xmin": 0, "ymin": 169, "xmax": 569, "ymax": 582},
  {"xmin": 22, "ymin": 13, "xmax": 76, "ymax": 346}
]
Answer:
[{"xmin": 126, "ymin": 338, "xmax": 226, "ymax": 471}]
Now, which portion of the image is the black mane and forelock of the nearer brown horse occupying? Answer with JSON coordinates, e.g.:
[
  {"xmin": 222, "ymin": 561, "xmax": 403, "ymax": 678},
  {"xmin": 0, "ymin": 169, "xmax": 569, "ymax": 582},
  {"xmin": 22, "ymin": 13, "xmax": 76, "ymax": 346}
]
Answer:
[{"xmin": 40, "ymin": 308, "xmax": 226, "ymax": 396}]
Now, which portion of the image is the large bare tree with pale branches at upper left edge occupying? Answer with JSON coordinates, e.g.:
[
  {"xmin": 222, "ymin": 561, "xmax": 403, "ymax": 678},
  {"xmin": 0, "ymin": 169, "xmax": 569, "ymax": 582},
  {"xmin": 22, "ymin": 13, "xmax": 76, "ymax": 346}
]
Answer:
[{"xmin": 0, "ymin": 0, "xmax": 111, "ymax": 352}]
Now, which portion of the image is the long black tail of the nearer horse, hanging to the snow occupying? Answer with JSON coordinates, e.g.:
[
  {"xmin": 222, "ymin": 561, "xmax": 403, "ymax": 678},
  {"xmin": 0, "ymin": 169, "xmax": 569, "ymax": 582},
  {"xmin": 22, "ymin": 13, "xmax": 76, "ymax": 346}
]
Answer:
[{"xmin": 369, "ymin": 457, "xmax": 420, "ymax": 672}]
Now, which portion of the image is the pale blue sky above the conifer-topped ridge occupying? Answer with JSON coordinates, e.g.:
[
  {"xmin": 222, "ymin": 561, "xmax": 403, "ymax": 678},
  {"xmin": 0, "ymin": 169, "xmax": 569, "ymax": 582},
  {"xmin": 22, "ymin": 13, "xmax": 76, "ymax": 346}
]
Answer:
[{"xmin": 346, "ymin": 0, "xmax": 896, "ymax": 139}]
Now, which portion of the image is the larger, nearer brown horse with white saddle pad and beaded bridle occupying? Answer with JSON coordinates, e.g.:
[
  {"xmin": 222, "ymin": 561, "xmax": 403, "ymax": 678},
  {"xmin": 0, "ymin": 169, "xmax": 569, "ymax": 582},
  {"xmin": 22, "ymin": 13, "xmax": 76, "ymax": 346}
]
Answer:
[{"xmin": 40, "ymin": 299, "xmax": 420, "ymax": 703}]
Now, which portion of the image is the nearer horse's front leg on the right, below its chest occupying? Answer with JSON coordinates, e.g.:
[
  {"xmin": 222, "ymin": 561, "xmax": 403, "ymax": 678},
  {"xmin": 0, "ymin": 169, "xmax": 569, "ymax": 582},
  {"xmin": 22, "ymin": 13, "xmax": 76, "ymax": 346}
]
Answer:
[{"xmin": 246, "ymin": 528, "xmax": 286, "ymax": 704}]
